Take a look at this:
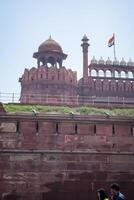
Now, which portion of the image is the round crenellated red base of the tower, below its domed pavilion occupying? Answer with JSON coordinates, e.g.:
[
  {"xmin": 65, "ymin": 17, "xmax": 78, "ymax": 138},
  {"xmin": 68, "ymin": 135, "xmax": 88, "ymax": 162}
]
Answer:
[{"xmin": 19, "ymin": 66, "xmax": 77, "ymax": 104}]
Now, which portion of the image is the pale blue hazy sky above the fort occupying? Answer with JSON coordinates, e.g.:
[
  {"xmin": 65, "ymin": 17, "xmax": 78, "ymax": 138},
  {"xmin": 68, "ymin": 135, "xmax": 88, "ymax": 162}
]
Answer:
[{"xmin": 0, "ymin": 0, "xmax": 134, "ymax": 93}]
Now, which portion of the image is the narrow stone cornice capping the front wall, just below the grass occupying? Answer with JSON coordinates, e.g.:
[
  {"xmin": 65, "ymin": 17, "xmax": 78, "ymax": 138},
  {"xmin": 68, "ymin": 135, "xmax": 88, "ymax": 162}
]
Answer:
[{"xmin": 0, "ymin": 113, "xmax": 134, "ymax": 124}]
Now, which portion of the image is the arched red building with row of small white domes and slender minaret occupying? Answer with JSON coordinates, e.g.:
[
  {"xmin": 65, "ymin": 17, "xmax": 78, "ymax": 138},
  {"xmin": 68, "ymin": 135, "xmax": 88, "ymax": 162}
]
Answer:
[{"xmin": 78, "ymin": 36, "xmax": 134, "ymax": 98}]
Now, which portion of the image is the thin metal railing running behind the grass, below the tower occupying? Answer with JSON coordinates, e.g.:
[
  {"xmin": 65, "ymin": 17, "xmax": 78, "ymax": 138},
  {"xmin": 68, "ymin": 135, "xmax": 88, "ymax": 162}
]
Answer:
[{"xmin": 0, "ymin": 92, "xmax": 134, "ymax": 106}]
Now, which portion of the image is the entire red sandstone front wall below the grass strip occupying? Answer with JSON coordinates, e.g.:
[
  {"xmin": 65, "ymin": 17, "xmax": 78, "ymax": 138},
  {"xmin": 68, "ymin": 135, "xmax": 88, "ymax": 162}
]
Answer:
[{"xmin": 0, "ymin": 114, "xmax": 134, "ymax": 200}]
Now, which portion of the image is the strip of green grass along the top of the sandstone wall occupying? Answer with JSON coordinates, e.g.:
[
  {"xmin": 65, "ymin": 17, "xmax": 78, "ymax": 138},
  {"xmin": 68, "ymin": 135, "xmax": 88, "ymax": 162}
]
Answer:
[{"xmin": 4, "ymin": 104, "xmax": 134, "ymax": 116}]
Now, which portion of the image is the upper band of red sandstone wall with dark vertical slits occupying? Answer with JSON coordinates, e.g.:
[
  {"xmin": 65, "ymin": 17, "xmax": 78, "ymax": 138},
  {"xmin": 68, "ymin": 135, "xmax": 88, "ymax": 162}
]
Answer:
[{"xmin": 0, "ymin": 115, "xmax": 134, "ymax": 152}]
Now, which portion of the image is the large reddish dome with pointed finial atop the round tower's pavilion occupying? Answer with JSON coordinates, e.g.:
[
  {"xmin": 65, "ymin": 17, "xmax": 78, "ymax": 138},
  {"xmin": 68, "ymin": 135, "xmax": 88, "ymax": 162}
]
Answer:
[{"xmin": 38, "ymin": 36, "xmax": 63, "ymax": 53}]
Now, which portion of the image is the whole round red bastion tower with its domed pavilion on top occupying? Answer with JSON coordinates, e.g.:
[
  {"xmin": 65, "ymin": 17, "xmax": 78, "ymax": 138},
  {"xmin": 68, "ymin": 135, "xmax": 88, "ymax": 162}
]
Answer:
[{"xmin": 19, "ymin": 36, "xmax": 77, "ymax": 104}]
